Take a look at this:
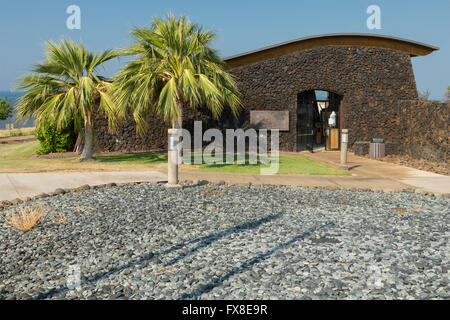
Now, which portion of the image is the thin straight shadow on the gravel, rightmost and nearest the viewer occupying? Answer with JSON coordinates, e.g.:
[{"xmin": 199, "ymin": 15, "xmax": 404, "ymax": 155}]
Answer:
[{"xmin": 180, "ymin": 223, "xmax": 334, "ymax": 300}]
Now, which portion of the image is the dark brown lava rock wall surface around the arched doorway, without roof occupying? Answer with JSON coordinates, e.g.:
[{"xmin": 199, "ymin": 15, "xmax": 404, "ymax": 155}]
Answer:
[{"xmin": 96, "ymin": 46, "xmax": 449, "ymax": 161}]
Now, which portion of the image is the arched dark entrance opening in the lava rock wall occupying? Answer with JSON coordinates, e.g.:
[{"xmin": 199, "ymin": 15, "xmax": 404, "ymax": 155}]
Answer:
[{"xmin": 297, "ymin": 90, "xmax": 342, "ymax": 152}]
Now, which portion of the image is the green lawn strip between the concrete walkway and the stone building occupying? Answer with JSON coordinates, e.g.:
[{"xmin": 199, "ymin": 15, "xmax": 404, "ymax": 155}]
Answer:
[{"xmin": 0, "ymin": 141, "xmax": 350, "ymax": 175}]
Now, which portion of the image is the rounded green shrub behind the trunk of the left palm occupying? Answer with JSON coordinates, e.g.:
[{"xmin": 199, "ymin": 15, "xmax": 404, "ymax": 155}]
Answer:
[{"xmin": 34, "ymin": 120, "xmax": 77, "ymax": 154}]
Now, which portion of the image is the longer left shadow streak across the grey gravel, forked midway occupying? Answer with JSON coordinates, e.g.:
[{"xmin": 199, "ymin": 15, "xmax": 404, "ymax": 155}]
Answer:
[{"xmin": 32, "ymin": 213, "xmax": 282, "ymax": 300}]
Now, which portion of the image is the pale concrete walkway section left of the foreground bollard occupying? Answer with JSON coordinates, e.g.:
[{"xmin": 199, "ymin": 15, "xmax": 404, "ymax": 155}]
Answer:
[{"xmin": 0, "ymin": 171, "xmax": 167, "ymax": 201}]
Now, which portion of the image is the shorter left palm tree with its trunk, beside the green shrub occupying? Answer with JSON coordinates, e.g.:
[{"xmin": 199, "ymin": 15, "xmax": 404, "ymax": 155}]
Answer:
[{"xmin": 17, "ymin": 40, "xmax": 119, "ymax": 160}]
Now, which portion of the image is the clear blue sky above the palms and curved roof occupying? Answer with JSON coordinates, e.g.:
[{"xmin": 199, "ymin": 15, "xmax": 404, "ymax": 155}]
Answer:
[{"xmin": 0, "ymin": 0, "xmax": 450, "ymax": 100}]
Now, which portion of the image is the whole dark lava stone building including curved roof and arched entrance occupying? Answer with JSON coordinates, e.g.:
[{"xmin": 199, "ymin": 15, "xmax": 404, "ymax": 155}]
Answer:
[{"xmin": 97, "ymin": 34, "xmax": 450, "ymax": 161}]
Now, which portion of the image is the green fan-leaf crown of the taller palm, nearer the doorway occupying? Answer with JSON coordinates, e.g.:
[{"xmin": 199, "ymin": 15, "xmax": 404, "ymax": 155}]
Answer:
[{"xmin": 114, "ymin": 15, "xmax": 241, "ymax": 185}]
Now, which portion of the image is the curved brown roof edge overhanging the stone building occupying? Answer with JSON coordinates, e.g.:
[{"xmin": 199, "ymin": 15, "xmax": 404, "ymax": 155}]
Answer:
[{"xmin": 224, "ymin": 33, "xmax": 439, "ymax": 69}]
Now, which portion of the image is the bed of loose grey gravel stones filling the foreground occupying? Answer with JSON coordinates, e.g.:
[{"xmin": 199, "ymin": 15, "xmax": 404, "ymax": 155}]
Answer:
[{"xmin": 0, "ymin": 184, "xmax": 450, "ymax": 299}]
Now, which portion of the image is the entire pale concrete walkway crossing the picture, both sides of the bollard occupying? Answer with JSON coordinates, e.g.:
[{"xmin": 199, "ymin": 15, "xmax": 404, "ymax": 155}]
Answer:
[{"xmin": 0, "ymin": 152, "xmax": 450, "ymax": 201}]
